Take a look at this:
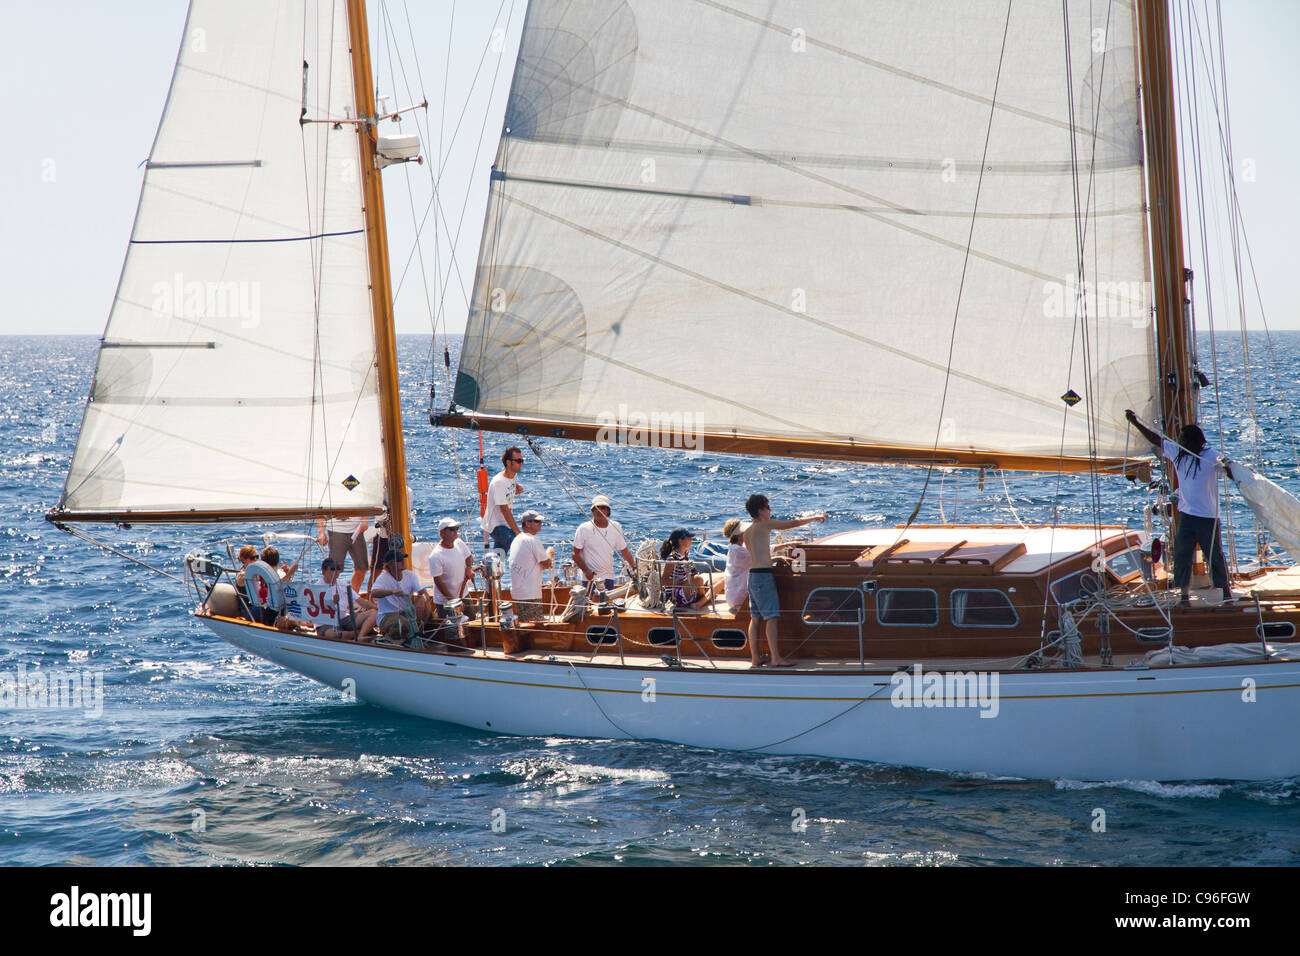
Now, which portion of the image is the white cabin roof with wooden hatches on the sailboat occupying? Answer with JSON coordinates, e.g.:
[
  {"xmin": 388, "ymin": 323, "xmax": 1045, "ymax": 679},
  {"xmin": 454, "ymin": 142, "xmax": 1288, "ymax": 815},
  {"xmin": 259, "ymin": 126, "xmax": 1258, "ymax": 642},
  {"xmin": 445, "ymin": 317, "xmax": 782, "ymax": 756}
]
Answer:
[{"xmin": 814, "ymin": 524, "xmax": 1127, "ymax": 574}]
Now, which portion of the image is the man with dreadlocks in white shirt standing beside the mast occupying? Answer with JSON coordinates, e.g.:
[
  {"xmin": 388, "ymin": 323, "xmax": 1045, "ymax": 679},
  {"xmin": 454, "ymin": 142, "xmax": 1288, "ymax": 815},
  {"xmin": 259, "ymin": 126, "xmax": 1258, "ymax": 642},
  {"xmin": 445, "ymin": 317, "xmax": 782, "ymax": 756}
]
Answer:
[{"xmin": 1125, "ymin": 408, "xmax": 1234, "ymax": 607}]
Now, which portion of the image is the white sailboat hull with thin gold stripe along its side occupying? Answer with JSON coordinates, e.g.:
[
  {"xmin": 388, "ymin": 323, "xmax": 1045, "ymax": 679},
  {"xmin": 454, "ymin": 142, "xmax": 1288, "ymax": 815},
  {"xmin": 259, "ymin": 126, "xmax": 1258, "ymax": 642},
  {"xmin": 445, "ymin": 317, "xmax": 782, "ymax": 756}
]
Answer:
[{"xmin": 204, "ymin": 619, "xmax": 1300, "ymax": 780}]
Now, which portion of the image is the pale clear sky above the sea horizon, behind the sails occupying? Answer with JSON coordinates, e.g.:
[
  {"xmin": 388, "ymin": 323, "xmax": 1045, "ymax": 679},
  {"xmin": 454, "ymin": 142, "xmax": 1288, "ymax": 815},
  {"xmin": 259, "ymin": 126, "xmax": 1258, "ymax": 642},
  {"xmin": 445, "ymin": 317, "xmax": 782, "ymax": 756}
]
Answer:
[{"xmin": 0, "ymin": 0, "xmax": 1300, "ymax": 334}]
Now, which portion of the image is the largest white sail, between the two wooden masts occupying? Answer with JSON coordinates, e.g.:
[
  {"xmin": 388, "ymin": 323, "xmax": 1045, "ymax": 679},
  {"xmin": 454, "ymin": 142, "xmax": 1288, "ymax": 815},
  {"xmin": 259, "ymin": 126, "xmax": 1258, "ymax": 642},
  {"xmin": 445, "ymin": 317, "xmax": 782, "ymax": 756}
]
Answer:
[{"xmin": 455, "ymin": 0, "xmax": 1156, "ymax": 457}]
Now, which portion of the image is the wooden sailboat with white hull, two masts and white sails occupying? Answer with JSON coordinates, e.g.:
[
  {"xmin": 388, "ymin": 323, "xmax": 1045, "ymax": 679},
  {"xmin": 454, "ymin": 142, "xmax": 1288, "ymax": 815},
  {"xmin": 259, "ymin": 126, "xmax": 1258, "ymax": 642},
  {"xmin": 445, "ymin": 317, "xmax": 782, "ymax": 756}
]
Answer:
[{"xmin": 49, "ymin": 0, "xmax": 1300, "ymax": 780}]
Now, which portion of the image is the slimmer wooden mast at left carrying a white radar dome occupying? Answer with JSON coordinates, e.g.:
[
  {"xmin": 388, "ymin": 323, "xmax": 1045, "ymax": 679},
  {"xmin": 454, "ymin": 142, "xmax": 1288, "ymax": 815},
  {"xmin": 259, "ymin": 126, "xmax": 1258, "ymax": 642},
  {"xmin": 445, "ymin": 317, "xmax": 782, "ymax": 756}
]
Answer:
[{"xmin": 347, "ymin": 0, "xmax": 411, "ymax": 548}]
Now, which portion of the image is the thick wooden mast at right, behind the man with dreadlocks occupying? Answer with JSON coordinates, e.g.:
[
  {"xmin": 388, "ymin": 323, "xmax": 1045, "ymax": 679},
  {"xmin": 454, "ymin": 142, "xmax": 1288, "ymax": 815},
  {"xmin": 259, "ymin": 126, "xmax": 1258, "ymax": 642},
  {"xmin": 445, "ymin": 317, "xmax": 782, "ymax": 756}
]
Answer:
[{"xmin": 1138, "ymin": 0, "xmax": 1197, "ymax": 437}]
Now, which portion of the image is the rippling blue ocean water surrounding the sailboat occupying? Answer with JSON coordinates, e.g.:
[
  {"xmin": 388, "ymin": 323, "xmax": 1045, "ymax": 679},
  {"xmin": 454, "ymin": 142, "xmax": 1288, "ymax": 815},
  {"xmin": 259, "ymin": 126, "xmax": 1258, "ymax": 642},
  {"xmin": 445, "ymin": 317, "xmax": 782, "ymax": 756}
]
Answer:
[{"xmin": 0, "ymin": 333, "xmax": 1300, "ymax": 866}]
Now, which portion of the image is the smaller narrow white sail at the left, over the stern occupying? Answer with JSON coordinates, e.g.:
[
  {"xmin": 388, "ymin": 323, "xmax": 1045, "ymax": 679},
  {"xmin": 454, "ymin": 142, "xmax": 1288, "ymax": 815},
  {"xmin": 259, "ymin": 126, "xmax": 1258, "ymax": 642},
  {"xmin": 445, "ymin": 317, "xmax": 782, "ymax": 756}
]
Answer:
[{"xmin": 60, "ymin": 0, "xmax": 384, "ymax": 515}]
